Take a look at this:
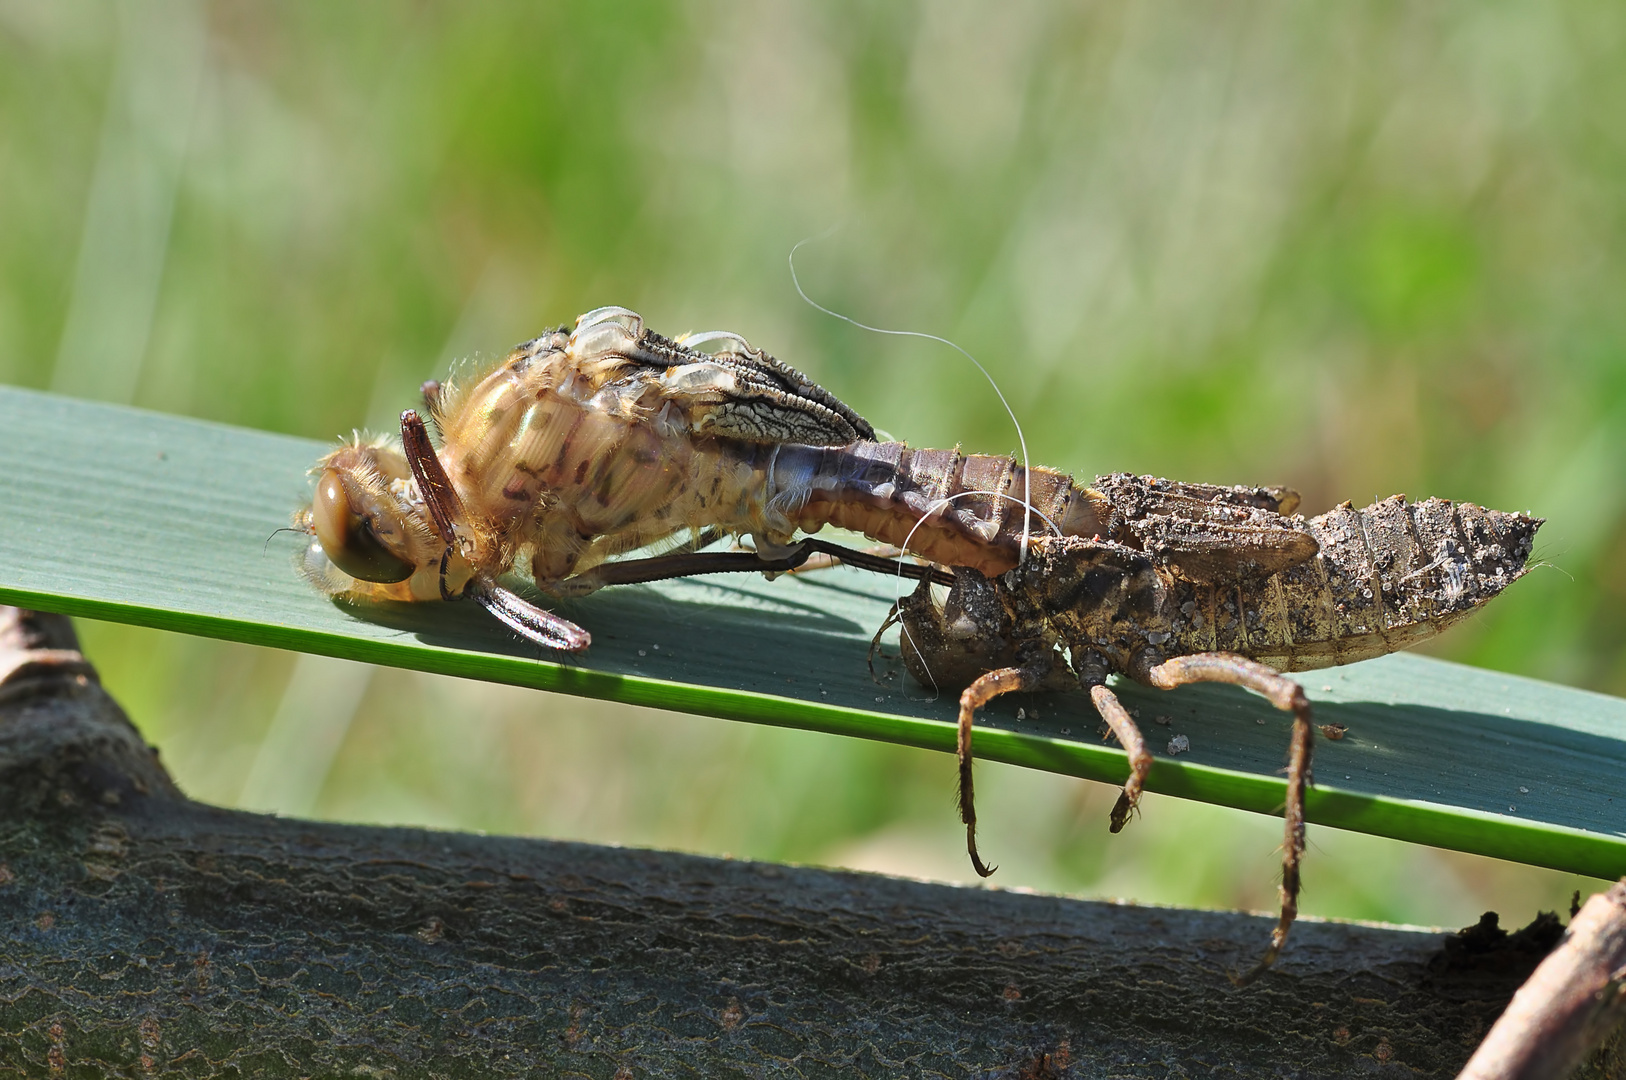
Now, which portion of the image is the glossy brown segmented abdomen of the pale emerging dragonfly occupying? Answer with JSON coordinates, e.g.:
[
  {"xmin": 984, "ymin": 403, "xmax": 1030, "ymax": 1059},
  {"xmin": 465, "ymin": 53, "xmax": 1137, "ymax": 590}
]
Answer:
[{"xmin": 774, "ymin": 442, "xmax": 1099, "ymax": 574}]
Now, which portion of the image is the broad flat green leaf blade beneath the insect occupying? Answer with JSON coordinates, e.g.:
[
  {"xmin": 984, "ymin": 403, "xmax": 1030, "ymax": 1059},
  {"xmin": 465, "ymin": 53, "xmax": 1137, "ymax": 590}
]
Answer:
[{"xmin": 9, "ymin": 387, "xmax": 1626, "ymax": 878}]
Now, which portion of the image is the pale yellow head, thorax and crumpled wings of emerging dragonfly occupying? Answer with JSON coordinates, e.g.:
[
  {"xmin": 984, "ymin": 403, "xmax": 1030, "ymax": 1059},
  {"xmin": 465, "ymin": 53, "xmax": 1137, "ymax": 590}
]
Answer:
[{"xmin": 296, "ymin": 309, "xmax": 873, "ymax": 600}]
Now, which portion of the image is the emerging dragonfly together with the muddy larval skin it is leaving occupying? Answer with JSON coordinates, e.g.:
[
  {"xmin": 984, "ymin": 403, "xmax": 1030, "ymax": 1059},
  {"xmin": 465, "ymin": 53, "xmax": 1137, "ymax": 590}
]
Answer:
[{"xmin": 294, "ymin": 307, "xmax": 1541, "ymax": 978}]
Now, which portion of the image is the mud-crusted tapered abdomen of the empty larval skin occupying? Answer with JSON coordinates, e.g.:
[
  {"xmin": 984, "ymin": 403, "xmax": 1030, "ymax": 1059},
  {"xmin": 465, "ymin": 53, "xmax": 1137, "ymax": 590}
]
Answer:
[{"xmin": 1209, "ymin": 496, "xmax": 1543, "ymax": 670}]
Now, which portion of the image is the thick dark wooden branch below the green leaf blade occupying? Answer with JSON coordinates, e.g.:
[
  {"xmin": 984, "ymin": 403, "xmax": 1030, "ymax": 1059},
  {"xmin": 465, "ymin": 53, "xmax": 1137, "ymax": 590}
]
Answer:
[{"xmin": 0, "ymin": 612, "xmax": 1623, "ymax": 1078}]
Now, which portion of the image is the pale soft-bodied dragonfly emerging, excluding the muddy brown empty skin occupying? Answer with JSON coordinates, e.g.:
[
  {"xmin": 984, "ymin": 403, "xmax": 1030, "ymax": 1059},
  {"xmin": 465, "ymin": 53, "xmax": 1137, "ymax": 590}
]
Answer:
[{"xmin": 294, "ymin": 300, "xmax": 1096, "ymax": 640}]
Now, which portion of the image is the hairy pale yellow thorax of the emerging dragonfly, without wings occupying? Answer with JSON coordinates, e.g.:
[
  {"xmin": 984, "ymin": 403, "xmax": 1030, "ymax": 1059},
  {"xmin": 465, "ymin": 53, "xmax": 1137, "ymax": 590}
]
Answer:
[{"xmin": 437, "ymin": 322, "xmax": 789, "ymax": 587}]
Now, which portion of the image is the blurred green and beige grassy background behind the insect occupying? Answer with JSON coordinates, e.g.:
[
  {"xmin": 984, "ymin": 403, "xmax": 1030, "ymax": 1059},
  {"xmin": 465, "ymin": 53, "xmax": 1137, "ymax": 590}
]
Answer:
[{"xmin": 0, "ymin": 0, "xmax": 1626, "ymax": 925}]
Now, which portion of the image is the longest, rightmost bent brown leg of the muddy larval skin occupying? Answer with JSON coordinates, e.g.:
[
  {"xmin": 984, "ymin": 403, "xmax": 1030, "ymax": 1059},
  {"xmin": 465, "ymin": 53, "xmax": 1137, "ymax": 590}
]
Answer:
[{"xmin": 1135, "ymin": 652, "xmax": 1315, "ymax": 986}]
